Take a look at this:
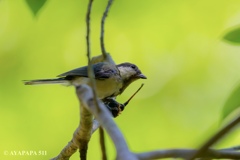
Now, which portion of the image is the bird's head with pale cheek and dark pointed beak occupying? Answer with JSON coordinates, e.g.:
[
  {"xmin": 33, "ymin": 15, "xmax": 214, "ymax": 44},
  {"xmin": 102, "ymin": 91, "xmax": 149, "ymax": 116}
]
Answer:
[{"xmin": 117, "ymin": 62, "xmax": 147, "ymax": 92}]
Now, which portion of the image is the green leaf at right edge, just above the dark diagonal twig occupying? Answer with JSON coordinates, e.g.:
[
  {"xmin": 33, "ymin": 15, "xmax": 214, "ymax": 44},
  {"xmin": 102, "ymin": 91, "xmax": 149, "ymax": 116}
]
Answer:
[{"xmin": 222, "ymin": 85, "xmax": 240, "ymax": 119}]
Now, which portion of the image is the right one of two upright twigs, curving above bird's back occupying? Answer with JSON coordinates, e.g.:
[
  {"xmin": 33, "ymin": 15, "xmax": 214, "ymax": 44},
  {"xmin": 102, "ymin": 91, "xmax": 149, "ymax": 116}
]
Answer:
[{"xmin": 100, "ymin": 0, "xmax": 113, "ymax": 59}]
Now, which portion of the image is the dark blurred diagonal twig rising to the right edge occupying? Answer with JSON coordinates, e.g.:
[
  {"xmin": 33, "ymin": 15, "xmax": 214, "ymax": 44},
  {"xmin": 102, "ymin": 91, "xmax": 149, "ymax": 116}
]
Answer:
[{"xmin": 189, "ymin": 116, "xmax": 240, "ymax": 160}]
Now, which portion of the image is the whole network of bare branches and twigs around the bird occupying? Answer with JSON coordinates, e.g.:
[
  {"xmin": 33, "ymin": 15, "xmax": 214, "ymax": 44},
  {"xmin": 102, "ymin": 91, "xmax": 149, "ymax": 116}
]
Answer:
[{"xmin": 47, "ymin": 0, "xmax": 240, "ymax": 160}]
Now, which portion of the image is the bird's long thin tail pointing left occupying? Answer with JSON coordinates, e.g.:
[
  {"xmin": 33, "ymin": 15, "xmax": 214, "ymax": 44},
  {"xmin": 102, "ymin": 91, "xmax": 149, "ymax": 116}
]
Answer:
[{"xmin": 23, "ymin": 78, "xmax": 69, "ymax": 85}]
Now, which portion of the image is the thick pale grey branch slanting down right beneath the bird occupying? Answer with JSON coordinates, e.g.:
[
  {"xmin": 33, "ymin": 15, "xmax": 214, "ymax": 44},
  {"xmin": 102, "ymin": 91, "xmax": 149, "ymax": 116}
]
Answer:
[{"xmin": 76, "ymin": 85, "xmax": 137, "ymax": 160}]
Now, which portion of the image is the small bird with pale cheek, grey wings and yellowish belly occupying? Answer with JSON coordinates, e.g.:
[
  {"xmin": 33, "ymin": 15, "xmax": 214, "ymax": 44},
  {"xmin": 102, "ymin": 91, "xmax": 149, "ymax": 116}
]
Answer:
[{"xmin": 24, "ymin": 62, "xmax": 147, "ymax": 99}]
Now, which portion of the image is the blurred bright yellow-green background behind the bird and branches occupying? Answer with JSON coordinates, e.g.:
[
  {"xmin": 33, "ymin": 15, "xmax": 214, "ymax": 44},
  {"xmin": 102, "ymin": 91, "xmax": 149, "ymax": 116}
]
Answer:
[{"xmin": 0, "ymin": 0, "xmax": 240, "ymax": 160}]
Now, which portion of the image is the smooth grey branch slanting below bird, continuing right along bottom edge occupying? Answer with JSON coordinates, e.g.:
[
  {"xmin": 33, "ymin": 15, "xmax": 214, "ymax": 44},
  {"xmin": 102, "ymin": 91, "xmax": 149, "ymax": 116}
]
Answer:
[{"xmin": 76, "ymin": 85, "xmax": 240, "ymax": 160}]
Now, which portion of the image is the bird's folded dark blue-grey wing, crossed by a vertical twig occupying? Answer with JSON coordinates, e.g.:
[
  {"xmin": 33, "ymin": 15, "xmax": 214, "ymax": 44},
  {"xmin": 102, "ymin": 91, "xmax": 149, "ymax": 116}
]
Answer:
[{"xmin": 57, "ymin": 62, "xmax": 118, "ymax": 79}]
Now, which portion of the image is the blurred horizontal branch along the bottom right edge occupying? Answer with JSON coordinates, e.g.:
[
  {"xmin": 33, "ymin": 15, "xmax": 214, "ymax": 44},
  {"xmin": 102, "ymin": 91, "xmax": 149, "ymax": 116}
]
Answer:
[{"xmin": 136, "ymin": 149, "xmax": 240, "ymax": 160}]
